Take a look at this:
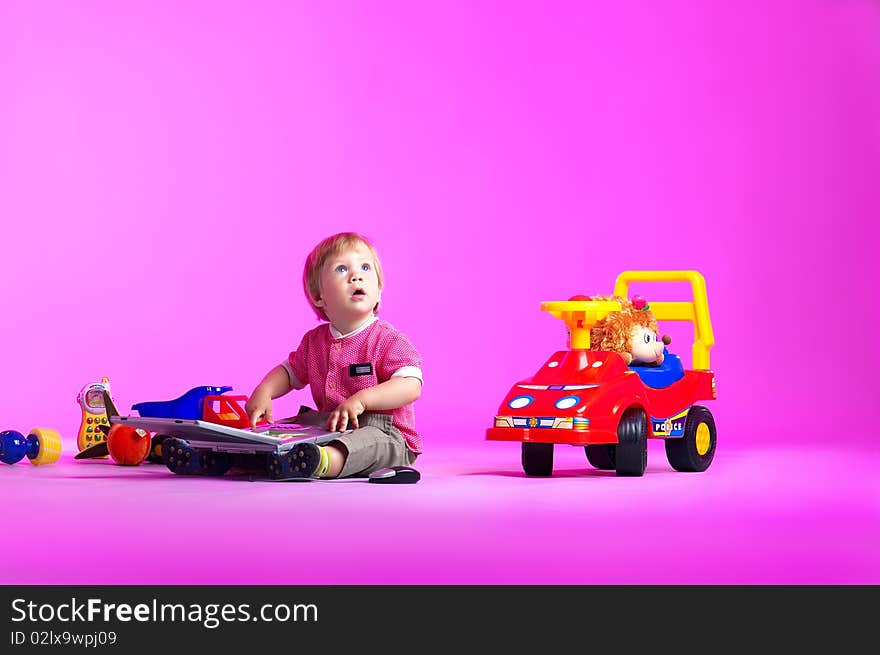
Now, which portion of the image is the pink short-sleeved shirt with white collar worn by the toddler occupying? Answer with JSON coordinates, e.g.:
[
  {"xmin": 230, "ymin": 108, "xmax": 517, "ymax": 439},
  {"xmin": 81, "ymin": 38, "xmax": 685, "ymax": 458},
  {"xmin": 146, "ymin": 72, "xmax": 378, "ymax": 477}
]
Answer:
[{"xmin": 282, "ymin": 317, "xmax": 422, "ymax": 453}]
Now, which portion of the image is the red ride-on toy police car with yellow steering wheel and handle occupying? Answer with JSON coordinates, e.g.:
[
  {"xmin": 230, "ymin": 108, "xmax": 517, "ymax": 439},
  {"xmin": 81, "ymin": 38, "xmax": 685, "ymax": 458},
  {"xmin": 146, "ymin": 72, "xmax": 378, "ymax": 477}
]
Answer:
[{"xmin": 486, "ymin": 271, "xmax": 716, "ymax": 476}]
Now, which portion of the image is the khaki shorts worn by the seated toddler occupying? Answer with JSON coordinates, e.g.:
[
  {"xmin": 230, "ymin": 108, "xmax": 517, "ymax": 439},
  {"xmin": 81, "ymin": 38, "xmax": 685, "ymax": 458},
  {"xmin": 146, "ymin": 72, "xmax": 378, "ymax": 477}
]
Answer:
[{"xmin": 285, "ymin": 407, "xmax": 418, "ymax": 478}]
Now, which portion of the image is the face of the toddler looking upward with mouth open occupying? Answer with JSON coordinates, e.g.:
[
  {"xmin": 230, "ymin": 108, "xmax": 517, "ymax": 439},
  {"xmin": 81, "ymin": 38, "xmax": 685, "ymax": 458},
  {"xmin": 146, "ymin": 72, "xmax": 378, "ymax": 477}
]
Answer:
[{"xmin": 315, "ymin": 243, "xmax": 380, "ymax": 326}]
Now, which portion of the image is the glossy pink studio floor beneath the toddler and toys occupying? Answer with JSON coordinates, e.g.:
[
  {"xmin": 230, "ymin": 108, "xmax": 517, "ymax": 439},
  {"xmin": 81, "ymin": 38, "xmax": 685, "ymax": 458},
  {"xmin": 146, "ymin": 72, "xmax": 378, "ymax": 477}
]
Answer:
[{"xmin": 0, "ymin": 442, "xmax": 880, "ymax": 584}]
